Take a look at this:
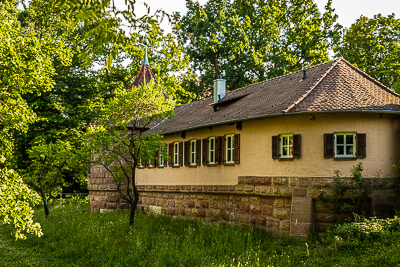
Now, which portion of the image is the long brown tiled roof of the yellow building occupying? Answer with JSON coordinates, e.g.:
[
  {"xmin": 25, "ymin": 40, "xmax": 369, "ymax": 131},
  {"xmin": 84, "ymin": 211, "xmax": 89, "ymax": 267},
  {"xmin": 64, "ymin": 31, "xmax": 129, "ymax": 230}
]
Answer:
[{"xmin": 148, "ymin": 58, "xmax": 400, "ymax": 134}]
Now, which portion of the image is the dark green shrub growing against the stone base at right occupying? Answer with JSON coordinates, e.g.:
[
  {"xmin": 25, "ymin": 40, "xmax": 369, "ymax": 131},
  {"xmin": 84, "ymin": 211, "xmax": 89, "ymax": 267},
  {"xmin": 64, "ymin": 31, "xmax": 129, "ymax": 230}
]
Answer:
[{"xmin": 313, "ymin": 162, "xmax": 393, "ymax": 217}]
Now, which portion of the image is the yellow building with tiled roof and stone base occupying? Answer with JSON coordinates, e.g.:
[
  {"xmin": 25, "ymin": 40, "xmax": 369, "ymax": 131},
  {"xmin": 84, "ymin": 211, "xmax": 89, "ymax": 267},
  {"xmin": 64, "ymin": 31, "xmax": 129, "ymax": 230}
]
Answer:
[{"xmin": 88, "ymin": 58, "xmax": 400, "ymax": 236}]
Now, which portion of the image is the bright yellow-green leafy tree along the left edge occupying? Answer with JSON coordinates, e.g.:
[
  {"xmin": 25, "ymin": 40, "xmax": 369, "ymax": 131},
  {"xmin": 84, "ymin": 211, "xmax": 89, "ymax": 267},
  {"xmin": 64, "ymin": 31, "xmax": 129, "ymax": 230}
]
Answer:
[{"xmin": 0, "ymin": 1, "xmax": 67, "ymax": 241}]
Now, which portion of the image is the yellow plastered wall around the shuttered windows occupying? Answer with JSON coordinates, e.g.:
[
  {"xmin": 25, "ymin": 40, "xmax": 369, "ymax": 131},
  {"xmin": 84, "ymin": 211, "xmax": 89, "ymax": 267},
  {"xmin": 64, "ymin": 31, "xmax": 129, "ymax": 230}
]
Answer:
[{"xmin": 137, "ymin": 113, "xmax": 400, "ymax": 185}]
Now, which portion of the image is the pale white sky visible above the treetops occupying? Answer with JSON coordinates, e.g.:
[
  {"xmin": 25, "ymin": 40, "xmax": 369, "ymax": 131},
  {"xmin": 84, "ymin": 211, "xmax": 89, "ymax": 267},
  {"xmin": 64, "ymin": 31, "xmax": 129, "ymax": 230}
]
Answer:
[{"xmin": 130, "ymin": 0, "xmax": 400, "ymax": 31}]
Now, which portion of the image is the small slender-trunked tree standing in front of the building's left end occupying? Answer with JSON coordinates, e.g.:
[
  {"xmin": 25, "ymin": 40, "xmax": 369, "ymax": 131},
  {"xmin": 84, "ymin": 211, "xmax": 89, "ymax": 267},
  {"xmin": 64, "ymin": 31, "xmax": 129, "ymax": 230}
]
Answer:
[{"xmin": 88, "ymin": 81, "xmax": 174, "ymax": 226}]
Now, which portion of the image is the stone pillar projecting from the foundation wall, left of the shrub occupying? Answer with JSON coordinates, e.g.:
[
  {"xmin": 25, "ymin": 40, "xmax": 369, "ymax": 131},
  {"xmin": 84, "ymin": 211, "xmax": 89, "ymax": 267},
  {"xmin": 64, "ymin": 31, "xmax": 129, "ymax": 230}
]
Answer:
[{"xmin": 290, "ymin": 196, "xmax": 314, "ymax": 237}]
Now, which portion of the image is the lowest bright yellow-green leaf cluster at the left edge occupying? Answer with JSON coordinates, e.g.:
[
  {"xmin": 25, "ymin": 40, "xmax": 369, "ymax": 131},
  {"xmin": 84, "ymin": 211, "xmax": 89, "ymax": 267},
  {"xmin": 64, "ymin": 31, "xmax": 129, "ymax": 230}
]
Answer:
[{"xmin": 0, "ymin": 168, "xmax": 42, "ymax": 239}]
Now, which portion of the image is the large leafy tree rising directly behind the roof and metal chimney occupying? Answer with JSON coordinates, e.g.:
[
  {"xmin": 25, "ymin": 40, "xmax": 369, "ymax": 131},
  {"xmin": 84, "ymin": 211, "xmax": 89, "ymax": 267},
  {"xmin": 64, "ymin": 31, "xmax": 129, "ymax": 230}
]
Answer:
[{"xmin": 176, "ymin": 0, "xmax": 340, "ymax": 95}]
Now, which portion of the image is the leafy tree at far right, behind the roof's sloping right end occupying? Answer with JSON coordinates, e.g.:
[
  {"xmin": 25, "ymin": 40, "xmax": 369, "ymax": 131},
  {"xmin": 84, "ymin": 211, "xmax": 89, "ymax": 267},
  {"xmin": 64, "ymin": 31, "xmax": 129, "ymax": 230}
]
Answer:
[{"xmin": 336, "ymin": 14, "xmax": 400, "ymax": 92}]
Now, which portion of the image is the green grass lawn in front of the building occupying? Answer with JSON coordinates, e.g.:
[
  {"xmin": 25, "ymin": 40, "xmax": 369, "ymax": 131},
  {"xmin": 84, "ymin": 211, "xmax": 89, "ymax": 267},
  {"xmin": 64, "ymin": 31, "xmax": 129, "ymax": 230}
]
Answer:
[{"xmin": 0, "ymin": 206, "xmax": 400, "ymax": 266}]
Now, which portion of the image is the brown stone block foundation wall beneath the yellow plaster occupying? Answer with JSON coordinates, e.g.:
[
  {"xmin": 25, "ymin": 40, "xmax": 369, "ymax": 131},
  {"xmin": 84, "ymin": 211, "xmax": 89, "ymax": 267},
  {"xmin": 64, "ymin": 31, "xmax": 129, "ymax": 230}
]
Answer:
[{"xmin": 88, "ymin": 171, "xmax": 396, "ymax": 237}]
